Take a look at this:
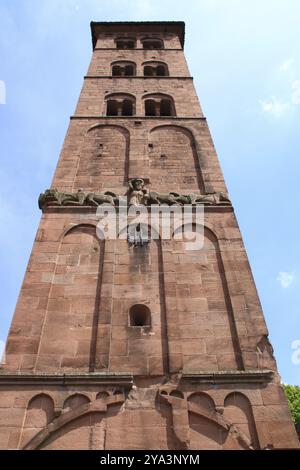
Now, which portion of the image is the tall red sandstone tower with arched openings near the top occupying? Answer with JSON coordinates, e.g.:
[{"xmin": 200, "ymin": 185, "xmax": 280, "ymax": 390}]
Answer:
[{"xmin": 0, "ymin": 22, "xmax": 298, "ymax": 450}]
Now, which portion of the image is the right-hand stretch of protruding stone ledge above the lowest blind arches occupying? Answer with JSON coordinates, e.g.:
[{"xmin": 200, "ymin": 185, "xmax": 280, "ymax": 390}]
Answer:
[{"xmin": 181, "ymin": 370, "xmax": 274, "ymax": 384}]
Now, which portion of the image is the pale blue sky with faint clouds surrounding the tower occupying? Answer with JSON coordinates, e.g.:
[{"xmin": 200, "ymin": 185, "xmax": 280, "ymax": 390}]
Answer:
[{"xmin": 0, "ymin": 0, "xmax": 300, "ymax": 385}]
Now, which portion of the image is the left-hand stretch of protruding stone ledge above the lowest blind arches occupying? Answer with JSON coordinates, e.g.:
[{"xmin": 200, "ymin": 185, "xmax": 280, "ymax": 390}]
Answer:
[{"xmin": 0, "ymin": 371, "xmax": 133, "ymax": 389}]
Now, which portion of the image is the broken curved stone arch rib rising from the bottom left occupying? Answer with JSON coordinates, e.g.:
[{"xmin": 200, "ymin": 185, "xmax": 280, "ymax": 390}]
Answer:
[{"xmin": 22, "ymin": 390, "xmax": 125, "ymax": 450}]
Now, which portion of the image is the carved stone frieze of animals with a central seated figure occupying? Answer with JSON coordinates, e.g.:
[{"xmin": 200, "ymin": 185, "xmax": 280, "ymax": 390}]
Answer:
[{"xmin": 39, "ymin": 178, "xmax": 231, "ymax": 209}]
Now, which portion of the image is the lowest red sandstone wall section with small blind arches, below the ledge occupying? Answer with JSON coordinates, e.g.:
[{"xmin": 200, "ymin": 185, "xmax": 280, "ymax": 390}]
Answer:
[{"xmin": 0, "ymin": 381, "xmax": 298, "ymax": 450}]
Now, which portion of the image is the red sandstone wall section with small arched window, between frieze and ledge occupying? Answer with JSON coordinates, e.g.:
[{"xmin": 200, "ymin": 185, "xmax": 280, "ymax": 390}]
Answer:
[{"xmin": 1, "ymin": 209, "xmax": 276, "ymax": 374}]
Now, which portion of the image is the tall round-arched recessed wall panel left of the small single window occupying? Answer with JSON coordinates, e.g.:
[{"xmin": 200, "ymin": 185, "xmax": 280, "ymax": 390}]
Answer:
[{"xmin": 36, "ymin": 223, "xmax": 105, "ymax": 371}]
